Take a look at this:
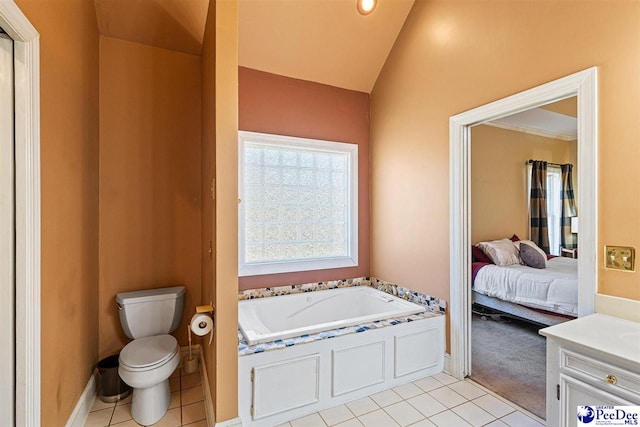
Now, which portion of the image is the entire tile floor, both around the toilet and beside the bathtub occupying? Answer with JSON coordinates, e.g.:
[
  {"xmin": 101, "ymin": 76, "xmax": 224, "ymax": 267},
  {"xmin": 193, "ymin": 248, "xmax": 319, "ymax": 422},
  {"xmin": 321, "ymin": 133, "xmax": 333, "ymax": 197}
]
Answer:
[{"xmin": 85, "ymin": 368, "xmax": 544, "ymax": 427}]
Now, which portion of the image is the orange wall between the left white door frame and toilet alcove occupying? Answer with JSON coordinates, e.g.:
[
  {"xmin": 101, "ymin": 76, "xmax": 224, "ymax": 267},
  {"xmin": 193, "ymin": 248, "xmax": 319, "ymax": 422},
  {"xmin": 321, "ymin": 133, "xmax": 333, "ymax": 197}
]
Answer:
[{"xmin": 17, "ymin": 0, "xmax": 98, "ymax": 427}]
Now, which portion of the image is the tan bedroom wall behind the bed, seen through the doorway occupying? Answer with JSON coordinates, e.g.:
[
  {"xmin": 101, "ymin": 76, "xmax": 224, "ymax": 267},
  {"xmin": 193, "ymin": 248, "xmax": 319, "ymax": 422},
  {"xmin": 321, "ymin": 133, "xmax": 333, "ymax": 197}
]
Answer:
[{"xmin": 471, "ymin": 125, "xmax": 578, "ymax": 243}]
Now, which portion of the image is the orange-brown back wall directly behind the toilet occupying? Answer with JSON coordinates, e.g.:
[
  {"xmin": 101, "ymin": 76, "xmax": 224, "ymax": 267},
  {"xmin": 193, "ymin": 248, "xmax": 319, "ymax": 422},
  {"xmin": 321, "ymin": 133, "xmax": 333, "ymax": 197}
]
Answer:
[{"xmin": 99, "ymin": 37, "xmax": 201, "ymax": 358}]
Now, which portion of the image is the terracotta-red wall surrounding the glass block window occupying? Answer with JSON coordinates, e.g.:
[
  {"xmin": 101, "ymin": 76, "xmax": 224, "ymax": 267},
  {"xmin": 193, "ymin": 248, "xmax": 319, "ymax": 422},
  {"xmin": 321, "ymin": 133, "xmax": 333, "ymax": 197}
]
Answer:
[{"xmin": 238, "ymin": 67, "xmax": 369, "ymax": 290}]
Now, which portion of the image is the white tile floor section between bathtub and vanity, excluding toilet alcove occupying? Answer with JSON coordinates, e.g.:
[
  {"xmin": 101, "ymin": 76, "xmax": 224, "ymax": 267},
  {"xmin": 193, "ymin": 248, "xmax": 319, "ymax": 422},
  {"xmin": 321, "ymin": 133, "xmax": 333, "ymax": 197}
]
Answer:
[{"xmin": 278, "ymin": 373, "xmax": 544, "ymax": 427}]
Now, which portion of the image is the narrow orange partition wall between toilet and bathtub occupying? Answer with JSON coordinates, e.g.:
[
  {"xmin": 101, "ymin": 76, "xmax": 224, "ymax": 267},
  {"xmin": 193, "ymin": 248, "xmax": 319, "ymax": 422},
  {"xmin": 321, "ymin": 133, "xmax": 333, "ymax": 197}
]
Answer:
[{"xmin": 202, "ymin": 0, "xmax": 238, "ymax": 422}]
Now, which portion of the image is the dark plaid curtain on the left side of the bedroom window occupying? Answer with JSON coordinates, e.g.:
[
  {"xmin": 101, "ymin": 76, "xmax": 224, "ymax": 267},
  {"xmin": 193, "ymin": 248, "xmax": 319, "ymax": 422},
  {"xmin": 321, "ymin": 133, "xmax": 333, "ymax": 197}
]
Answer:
[{"xmin": 529, "ymin": 160, "xmax": 549, "ymax": 253}]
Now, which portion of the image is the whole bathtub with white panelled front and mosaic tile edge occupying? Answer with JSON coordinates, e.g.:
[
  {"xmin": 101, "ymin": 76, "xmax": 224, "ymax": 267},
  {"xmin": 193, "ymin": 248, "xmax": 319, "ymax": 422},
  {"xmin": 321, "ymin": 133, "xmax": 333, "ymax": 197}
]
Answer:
[{"xmin": 238, "ymin": 286, "xmax": 445, "ymax": 427}]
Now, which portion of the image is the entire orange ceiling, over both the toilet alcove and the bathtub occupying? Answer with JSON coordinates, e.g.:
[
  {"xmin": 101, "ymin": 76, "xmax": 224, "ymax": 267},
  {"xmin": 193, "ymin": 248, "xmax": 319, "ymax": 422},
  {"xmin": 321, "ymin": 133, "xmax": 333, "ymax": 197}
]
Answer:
[{"xmin": 95, "ymin": 0, "xmax": 414, "ymax": 93}]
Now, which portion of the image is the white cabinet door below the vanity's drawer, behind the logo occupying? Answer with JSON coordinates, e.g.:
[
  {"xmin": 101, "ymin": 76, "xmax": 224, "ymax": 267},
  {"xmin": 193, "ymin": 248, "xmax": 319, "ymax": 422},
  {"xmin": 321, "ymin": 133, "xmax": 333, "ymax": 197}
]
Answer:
[{"xmin": 560, "ymin": 374, "xmax": 633, "ymax": 427}]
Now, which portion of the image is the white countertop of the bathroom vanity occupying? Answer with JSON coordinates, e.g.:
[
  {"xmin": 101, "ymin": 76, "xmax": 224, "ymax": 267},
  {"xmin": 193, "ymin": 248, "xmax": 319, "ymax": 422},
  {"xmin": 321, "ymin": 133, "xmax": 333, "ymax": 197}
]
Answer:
[{"xmin": 540, "ymin": 313, "xmax": 640, "ymax": 363}]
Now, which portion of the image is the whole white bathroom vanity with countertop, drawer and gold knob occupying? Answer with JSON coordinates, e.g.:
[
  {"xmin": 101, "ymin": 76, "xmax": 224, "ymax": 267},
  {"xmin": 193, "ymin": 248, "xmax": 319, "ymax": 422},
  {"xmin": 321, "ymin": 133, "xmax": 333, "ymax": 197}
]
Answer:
[{"xmin": 540, "ymin": 314, "xmax": 640, "ymax": 427}]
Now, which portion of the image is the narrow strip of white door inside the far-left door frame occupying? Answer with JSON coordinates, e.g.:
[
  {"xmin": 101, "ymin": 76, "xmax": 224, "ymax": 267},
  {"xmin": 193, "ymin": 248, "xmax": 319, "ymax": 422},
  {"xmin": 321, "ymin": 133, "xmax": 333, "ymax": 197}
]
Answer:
[{"xmin": 0, "ymin": 29, "xmax": 16, "ymax": 426}]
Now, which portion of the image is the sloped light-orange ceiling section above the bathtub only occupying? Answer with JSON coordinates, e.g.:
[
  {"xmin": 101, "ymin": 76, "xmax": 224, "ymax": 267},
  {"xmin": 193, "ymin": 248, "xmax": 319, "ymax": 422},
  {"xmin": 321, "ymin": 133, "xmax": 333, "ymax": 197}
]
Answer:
[{"xmin": 238, "ymin": 0, "xmax": 414, "ymax": 93}]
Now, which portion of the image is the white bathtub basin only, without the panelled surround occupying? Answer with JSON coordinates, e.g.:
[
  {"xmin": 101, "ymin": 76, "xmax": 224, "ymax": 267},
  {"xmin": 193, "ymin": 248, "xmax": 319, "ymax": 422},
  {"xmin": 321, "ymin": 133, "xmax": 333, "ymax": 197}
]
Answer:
[{"xmin": 238, "ymin": 286, "xmax": 425, "ymax": 345}]
